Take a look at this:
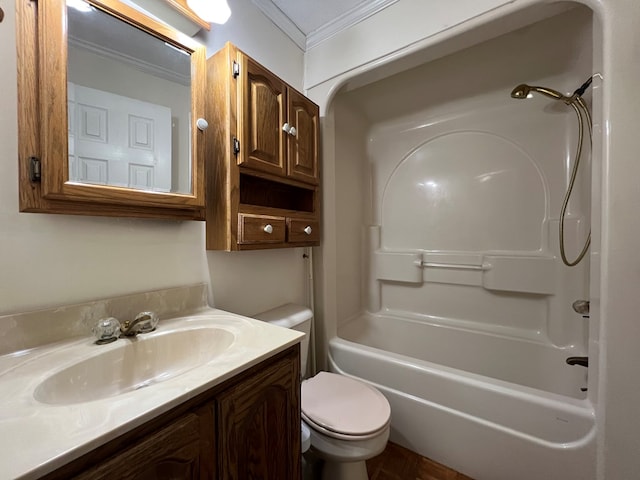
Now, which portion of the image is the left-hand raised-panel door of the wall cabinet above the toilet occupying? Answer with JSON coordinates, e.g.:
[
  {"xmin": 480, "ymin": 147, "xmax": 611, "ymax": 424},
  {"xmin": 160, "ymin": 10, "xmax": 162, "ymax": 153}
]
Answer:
[{"xmin": 238, "ymin": 54, "xmax": 287, "ymax": 176}]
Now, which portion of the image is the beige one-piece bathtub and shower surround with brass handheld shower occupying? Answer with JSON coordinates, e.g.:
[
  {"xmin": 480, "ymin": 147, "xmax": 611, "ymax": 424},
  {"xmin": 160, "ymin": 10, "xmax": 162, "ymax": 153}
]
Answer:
[{"xmin": 329, "ymin": 6, "xmax": 602, "ymax": 480}]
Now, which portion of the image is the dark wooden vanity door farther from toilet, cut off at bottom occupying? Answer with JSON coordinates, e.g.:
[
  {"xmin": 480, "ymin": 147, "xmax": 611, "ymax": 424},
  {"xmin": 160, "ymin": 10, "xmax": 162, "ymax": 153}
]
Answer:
[{"xmin": 74, "ymin": 406, "xmax": 215, "ymax": 480}]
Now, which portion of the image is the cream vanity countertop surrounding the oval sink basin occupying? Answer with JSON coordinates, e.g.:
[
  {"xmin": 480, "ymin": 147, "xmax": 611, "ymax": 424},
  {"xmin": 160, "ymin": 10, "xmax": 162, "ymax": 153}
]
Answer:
[{"xmin": 0, "ymin": 308, "xmax": 302, "ymax": 479}]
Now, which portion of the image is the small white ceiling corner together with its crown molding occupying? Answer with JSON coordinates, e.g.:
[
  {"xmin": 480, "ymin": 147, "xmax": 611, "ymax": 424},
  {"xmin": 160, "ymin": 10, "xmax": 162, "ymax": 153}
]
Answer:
[{"xmin": 253, "ymin": 0, "xmax": 398, "ymax": 51}]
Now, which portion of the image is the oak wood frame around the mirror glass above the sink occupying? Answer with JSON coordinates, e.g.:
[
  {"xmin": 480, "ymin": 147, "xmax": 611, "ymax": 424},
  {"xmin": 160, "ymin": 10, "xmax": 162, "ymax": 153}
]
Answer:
[{"xmin": 16, "ymin": 0, "xmax": 206, "ymax": 220}]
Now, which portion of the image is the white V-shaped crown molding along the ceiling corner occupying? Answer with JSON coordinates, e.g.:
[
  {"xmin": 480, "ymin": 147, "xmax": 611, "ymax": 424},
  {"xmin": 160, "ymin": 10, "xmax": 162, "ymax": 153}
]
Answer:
[{"xmin": 252, "ymin": 0, "xmax": 398, "ymax": 52}]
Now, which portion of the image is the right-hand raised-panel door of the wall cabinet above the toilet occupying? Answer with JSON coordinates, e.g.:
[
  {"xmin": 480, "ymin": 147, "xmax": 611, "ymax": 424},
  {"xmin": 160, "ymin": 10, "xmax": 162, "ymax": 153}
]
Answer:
[{"xmin": 287, "ymin": 89, "xmax": 320, "ymax": 185}]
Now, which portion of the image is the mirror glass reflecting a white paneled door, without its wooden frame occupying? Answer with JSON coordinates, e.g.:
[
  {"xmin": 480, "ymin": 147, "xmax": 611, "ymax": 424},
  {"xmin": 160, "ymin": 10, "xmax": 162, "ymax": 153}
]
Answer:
[{"xmin": 67, "ymin": 1, "xmax": 192, "ymax": 193}]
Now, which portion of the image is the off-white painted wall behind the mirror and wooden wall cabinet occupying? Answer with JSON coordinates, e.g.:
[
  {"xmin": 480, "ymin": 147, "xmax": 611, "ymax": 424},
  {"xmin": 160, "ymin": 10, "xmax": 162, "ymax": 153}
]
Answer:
[{"xmin": 0, "ymin": 0, "xmax": 305, "ymax": 314}]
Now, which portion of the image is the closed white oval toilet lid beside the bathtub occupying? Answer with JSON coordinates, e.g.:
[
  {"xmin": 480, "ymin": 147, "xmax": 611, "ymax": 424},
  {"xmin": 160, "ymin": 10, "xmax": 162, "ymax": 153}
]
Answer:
[{"xmin": 301, "ymin": 372, "xmax": 391, "ymax": 436}]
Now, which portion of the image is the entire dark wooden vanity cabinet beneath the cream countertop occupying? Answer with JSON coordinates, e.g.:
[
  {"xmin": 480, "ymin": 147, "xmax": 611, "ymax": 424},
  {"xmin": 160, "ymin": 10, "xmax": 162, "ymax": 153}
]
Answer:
[{"xmin": 43, "ymin": 344, "xmax": 301, "ymax": 480}]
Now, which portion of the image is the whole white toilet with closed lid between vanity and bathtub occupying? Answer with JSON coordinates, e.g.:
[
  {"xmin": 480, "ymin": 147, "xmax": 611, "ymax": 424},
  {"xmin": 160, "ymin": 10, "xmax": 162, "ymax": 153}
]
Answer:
[{"xmin": 255, "ymin": 303, "xmax": 391, "ymax": 480}]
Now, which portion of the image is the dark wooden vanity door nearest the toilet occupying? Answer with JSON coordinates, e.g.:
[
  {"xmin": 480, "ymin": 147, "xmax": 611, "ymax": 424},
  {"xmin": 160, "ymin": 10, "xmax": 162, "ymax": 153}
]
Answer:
[{"xmin": 218, "ymin": 349, "xmax": 301, "ymax": 480}]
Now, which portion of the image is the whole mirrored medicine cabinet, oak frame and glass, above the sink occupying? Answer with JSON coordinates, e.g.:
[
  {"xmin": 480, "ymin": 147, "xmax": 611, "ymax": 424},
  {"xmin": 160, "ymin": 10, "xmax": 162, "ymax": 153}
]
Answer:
[{"xmin": 16, "ymin": 0, "xmax": 205, "ymax": 219}]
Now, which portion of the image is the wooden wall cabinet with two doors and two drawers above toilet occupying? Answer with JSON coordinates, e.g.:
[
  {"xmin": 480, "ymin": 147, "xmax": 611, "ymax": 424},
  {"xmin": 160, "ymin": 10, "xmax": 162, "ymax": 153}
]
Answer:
[{"xmin": 205, "ymin": 43, "xmax": 320, "ymax": 250}]
